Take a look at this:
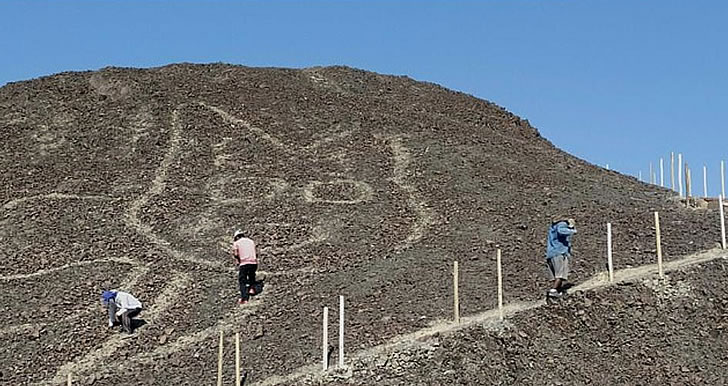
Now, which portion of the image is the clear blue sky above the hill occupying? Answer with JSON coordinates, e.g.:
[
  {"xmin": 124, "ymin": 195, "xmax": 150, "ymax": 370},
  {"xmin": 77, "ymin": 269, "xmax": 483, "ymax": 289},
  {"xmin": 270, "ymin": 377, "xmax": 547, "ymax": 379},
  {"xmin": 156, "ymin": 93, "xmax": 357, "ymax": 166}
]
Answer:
[{"xmin": 0, "ymin": 0, "xmax": 728, "ymax": 193}]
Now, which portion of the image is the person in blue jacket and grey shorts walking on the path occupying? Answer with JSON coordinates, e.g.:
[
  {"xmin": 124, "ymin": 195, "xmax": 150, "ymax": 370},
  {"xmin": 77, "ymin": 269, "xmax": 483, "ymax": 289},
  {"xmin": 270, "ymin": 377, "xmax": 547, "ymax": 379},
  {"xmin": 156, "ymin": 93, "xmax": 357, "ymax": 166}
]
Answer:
[{"xmin": 546, "ymin": 218, "xmax": 576, "ymax": 297}]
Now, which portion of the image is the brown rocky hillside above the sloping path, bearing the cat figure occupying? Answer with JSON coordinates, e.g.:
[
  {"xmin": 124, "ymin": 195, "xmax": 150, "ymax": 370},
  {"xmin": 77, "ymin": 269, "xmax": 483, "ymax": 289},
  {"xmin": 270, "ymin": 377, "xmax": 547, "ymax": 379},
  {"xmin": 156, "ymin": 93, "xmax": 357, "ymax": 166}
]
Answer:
[{"xmin": 0, "ymin": 64, "xmax": 719, "ymax": 385}]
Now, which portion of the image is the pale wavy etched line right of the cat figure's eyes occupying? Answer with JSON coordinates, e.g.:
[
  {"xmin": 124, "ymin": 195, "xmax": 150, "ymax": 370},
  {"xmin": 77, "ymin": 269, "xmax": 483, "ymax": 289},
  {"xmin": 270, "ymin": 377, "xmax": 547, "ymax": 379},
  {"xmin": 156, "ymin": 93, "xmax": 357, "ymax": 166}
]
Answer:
[{"xmin": 378, "ymin": 136, "xmax": 436, "ymax": 249}]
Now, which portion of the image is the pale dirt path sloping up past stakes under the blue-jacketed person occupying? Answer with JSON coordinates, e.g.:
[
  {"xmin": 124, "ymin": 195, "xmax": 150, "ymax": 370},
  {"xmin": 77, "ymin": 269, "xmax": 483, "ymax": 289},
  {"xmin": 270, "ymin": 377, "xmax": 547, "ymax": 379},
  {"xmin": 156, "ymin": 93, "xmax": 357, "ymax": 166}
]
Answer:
[{"xmin": 253, "ymin": 249, "xmax": 728, "ymax": 386}]
